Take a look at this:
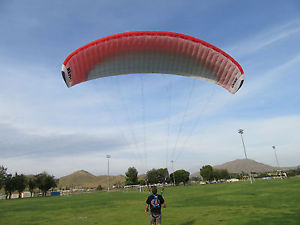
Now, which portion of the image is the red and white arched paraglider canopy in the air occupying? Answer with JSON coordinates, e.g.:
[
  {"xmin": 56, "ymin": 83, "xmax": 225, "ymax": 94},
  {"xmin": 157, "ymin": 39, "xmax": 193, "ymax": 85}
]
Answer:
[{"xmin": 62, "ymin": 31, "xmax": 244, "ymax": 94}]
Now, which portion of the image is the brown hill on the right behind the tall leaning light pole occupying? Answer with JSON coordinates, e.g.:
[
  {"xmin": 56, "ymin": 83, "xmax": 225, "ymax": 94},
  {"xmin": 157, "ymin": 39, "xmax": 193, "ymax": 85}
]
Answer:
[{"xmin": 191, "ymin": 159, "xmax": 277, "ymax": 177}]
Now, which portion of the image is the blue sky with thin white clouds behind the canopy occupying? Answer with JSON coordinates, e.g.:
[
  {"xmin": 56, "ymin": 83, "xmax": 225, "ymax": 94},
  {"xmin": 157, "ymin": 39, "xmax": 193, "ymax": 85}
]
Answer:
[{"xmin": 0, "ymin": 0, "xmax": 300, "ymax": 177}]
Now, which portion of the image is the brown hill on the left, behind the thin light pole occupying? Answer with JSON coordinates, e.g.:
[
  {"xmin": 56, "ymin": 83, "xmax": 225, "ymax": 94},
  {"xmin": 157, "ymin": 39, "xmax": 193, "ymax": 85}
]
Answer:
[{"xmin": 58, "ymin": 170, "xmax": 125, "ymax": 188}]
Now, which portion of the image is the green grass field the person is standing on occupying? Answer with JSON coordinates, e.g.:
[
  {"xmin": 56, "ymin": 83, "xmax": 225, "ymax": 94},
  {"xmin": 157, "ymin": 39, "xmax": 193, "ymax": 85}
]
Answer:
[{"xmin": 0, "ymin": 178, "xmax": 300, "ymax": 225}]
